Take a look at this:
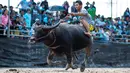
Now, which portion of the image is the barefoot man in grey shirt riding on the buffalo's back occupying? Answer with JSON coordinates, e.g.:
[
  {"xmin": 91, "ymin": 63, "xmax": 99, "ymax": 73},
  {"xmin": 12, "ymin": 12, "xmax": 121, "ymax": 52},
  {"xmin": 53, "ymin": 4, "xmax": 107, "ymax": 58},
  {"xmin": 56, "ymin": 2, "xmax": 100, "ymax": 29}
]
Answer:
[{"xmin": 68, "ymin": 1, "xmax": 92, "ymax": 36}]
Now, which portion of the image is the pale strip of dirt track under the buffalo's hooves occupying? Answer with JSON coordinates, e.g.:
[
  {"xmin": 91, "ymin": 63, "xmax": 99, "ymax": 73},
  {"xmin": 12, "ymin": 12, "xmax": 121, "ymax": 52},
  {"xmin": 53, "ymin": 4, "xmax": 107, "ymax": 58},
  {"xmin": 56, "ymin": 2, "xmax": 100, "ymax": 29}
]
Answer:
[{"xmin": 0, "ymin": 68, "xmax": 130, "ymax": 73}]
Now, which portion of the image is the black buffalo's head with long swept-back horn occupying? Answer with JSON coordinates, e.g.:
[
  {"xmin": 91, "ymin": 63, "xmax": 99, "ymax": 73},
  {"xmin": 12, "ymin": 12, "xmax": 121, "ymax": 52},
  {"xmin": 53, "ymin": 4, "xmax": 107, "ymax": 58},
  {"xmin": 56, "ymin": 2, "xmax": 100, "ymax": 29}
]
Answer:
[{"xmin": 29, "ymin": 21, "xmax": 60, "ymax": 43}]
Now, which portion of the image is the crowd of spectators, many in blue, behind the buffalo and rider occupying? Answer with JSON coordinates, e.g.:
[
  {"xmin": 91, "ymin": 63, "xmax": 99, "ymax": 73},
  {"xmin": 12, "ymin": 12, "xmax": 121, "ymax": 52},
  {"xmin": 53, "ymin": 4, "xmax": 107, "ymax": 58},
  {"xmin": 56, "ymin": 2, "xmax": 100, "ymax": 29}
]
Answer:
[{"xmin": 0, "ymin": 0, "xmax": 130, "ymax": 39}]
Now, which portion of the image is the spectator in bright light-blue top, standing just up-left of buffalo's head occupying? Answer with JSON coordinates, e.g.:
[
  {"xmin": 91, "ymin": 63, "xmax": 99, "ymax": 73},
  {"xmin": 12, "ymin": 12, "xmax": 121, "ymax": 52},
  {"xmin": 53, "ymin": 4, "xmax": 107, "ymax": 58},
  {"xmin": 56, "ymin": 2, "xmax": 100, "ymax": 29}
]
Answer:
[{"xmin": 24, "ymin": 9, "xmax": 31, "ymax": 28}]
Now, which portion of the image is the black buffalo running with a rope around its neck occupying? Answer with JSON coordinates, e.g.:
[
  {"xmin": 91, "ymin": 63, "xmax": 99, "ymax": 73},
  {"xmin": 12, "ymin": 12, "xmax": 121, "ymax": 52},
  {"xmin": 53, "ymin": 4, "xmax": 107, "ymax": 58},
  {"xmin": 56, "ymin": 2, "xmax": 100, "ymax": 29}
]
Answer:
[{"xmin": 30, "ymin": 22, "xmax": 92, "ymax": 70}]
